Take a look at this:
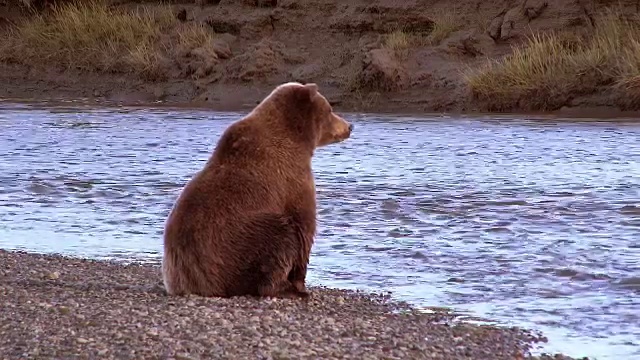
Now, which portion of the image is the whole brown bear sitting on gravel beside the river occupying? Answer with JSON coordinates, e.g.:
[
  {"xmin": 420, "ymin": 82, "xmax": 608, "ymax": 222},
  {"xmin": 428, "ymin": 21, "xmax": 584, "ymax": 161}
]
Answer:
[{"xmin": 162, "ymin": 82, "xmax": 353, "ymax": 298}]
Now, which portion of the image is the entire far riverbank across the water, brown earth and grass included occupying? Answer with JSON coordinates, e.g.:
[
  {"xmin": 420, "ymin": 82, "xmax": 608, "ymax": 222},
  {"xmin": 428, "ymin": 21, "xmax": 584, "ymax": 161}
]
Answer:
[{"xmin": 0, "ymin": 0, "xmax": 640, "ymax": 117}]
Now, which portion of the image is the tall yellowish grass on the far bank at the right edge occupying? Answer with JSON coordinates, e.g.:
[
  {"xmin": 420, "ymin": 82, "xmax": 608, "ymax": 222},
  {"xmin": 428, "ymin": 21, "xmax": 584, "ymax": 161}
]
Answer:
[{"xmin": 465, "ymin": 11, "xmax": 640, "ymax": 111}]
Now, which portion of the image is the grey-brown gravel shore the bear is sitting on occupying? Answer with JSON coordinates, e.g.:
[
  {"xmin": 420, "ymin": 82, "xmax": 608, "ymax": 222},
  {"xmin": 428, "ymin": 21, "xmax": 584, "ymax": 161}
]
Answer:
[{"xmin": 0, "ymin": 250, "xmax": 592, "ymax": 360}]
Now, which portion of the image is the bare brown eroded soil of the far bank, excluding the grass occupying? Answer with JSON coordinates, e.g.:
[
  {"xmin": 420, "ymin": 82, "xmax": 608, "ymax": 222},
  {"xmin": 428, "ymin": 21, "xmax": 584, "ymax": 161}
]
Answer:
[{"xmin": 0, "ymin": 0, "xmax": 640, "ymax": 116}]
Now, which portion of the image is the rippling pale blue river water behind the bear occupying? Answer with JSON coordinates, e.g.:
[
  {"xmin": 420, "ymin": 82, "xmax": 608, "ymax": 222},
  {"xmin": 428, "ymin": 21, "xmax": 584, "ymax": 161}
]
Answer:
[{"xmin": 0, "ymin": 103, "xmax": 640, "ymax": 360}]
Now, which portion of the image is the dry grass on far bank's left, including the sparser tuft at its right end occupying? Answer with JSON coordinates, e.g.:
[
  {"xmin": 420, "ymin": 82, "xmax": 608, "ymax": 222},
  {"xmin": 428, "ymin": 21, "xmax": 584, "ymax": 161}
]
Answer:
[{"xmin": 0, "ymin": 0, "xmax": 220, "ymax": 79}]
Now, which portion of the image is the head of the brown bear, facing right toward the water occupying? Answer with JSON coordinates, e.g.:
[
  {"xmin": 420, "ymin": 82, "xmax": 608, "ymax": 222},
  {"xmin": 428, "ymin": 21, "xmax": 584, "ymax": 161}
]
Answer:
[{"xmin": 259, "ymin": 82, "xmax": 353, "ymax": 148}]
